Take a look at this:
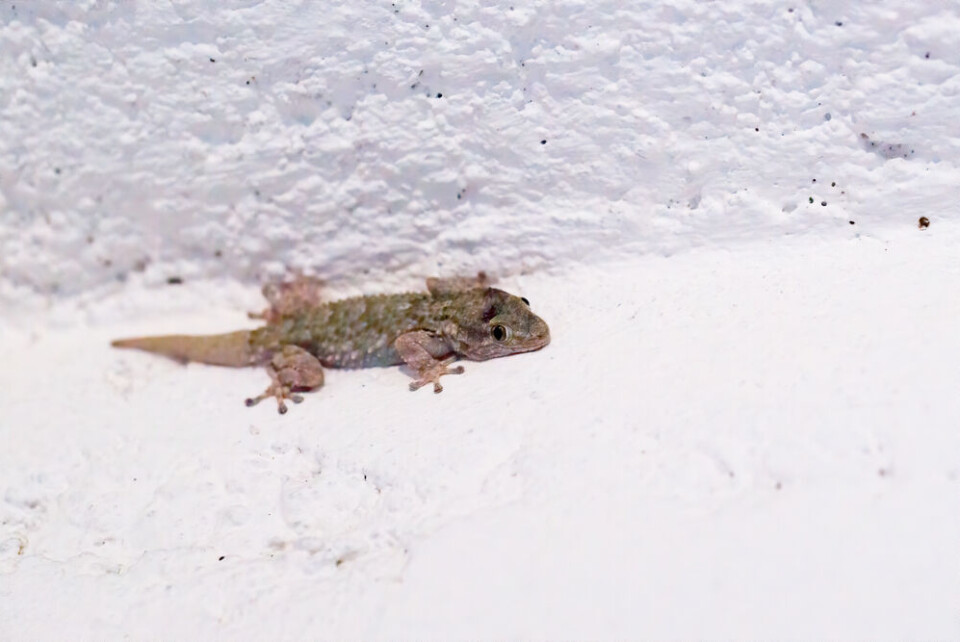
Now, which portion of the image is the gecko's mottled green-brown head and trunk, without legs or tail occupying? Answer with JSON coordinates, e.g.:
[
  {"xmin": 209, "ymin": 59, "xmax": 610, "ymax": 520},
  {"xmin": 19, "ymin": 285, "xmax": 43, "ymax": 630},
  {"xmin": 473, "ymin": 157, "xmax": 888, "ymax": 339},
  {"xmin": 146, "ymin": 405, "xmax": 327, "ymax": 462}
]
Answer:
[{"xmin": 250, "ymin": 287, "xmax": 549, "ymax": 368}]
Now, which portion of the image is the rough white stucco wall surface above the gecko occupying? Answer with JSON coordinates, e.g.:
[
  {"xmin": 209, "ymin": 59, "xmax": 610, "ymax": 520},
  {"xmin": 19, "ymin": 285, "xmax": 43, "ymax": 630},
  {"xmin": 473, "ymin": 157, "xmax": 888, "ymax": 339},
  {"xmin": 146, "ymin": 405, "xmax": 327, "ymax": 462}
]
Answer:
[{"xmin": 0, "ymin": 0, "xmax": 960, "ymax": 308}]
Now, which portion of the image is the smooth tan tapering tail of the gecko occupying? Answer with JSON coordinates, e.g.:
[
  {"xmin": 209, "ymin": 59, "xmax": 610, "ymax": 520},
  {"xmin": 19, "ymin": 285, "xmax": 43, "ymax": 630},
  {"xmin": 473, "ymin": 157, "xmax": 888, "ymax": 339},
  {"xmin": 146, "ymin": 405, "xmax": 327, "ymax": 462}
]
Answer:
[{"xmin": 110, "ymin": 330, "xmax": 256, "ymax": 367}]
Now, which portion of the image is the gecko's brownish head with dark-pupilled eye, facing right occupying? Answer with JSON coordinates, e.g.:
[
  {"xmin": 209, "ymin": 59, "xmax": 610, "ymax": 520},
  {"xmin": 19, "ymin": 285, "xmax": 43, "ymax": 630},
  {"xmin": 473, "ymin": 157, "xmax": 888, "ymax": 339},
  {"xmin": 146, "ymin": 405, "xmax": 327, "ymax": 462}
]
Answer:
[{"xmin": 460, "ymin": 288, "xmax": 550, "ymax": 361}]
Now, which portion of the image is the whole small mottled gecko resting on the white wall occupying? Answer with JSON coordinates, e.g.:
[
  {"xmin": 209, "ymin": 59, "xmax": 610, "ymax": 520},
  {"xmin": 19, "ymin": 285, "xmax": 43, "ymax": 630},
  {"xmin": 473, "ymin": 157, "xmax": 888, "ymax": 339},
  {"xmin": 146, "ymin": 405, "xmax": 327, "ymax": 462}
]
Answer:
[{"xmin": 111, "ymin": 272, "xmax": 550, "ymax": 414}]
